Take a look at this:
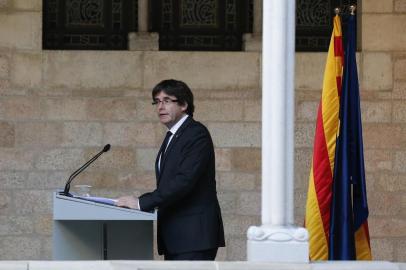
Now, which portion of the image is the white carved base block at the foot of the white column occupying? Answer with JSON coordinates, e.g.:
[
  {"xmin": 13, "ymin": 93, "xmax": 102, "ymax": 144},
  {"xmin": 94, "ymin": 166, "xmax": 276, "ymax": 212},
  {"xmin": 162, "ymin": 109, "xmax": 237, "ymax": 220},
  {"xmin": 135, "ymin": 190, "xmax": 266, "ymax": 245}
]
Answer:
[{"xmin": 247, "ymin": 225, "xmax": 309, "ymax": 263}]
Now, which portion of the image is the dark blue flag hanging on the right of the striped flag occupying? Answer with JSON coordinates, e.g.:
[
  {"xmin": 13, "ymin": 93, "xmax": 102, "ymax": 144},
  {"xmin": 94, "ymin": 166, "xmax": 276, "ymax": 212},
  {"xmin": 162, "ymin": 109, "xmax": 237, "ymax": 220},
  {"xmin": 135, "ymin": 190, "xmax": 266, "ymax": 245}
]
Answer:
[{"xmin": 329, "ymin": 15, "xmax": 370, "ymax": 260}]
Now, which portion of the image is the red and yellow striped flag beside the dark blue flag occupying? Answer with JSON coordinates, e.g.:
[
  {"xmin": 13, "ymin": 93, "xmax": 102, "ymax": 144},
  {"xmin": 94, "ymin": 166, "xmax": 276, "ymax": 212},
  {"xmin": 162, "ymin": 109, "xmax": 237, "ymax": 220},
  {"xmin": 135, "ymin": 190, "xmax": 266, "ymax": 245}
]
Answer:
[{"xmin": 305, "ymin": 15, "xmax": 343, "ymax": 260}]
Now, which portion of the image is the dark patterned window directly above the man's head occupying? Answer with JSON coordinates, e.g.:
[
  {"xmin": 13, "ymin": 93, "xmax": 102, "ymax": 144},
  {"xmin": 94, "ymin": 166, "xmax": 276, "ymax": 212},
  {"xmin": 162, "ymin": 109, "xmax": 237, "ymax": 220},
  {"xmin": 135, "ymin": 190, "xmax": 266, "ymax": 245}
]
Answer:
[{"xmin": 149, "ymin": 0, "xmax": 253, "ymax": 51}]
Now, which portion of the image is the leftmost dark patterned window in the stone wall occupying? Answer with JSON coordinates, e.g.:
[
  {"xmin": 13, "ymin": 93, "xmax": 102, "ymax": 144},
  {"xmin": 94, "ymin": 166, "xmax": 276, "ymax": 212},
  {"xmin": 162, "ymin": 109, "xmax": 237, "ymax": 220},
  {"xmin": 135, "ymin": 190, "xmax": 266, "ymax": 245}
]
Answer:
[{"xmin": 42, "ymin": 0, "xmax": 138, "ymax": 50}]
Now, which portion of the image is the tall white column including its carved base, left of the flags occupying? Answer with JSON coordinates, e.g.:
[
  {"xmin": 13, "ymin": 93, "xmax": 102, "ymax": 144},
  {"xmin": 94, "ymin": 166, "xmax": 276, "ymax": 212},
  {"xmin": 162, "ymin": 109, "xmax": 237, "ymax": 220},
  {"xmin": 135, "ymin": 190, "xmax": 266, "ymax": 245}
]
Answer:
[{"xmin": 247, "ymin": 0, "xmax": 309, "ymax": 262}]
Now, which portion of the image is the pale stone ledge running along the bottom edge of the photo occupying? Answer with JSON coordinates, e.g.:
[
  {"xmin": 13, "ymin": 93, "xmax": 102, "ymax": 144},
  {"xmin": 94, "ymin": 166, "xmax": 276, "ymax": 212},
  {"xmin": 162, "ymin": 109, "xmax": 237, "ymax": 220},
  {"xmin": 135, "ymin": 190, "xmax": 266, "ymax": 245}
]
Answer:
[{"xmin": 0, "ymin": 261, "xmax": 406, "ymax": 270}]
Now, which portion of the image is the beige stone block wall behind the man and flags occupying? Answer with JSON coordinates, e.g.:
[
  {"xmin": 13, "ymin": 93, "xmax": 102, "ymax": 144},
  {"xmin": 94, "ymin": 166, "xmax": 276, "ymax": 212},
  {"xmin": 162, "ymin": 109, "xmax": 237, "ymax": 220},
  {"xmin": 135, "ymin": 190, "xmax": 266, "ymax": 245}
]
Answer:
[{"xmin": 0, "ymin": 0, "xmax": 406, "ymax": 261}]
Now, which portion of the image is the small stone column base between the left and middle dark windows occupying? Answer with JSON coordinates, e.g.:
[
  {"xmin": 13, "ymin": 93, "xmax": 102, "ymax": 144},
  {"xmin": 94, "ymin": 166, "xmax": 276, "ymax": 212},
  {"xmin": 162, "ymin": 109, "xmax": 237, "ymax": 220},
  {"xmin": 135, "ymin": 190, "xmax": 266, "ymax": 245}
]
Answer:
[{"xmin": 128, "ymin": 32, "xmax": 159, "ymax": 51}]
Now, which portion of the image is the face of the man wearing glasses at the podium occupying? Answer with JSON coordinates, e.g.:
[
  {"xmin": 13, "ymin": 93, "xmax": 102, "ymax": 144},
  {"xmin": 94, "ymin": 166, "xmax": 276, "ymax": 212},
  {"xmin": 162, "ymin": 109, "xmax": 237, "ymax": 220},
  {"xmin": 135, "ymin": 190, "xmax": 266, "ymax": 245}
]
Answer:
[{"xmin": 154, "ymin": 91, "xmax": 187, "ymax": 129}]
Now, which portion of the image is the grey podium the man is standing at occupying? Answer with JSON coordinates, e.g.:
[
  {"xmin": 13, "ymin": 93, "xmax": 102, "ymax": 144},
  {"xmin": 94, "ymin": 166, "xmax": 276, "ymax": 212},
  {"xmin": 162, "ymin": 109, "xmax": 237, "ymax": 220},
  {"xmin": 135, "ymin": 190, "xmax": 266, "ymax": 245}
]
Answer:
[{"xmin": 53, "ymin": 192, "xmax": 156, "ymax": 260}]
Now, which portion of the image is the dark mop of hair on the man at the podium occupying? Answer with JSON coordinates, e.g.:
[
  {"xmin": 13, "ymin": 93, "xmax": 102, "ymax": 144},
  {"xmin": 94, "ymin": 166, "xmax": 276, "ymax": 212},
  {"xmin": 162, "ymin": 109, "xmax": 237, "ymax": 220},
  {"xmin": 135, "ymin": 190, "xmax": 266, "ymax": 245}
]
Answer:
[{"xmin": 152, "ymin": 80, "xmax": 195, "ymax": 117}]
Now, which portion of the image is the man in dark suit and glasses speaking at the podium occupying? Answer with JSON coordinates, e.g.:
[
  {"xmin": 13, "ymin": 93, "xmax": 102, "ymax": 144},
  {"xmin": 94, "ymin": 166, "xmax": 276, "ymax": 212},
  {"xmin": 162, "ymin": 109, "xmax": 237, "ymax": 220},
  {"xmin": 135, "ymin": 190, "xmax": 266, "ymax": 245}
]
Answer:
[{"xmin": 117, "ymin": 80, "xmax": 225, "ymax": 260}]
